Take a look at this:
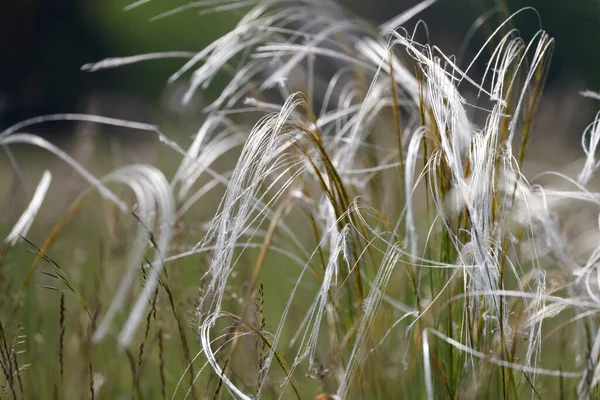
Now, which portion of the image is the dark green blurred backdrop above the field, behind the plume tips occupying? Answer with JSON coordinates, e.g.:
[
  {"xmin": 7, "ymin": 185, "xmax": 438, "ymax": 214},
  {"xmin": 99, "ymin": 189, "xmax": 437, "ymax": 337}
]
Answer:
[{"xmin": 0, "ymin": 0, "xmax": 600, "ymax": 136}]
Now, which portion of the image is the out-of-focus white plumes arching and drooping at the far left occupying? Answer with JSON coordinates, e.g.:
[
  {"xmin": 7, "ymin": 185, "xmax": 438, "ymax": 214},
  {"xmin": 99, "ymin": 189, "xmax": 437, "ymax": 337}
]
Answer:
[{"xmin": 0, "ymin": 114, "xmax": 178, "ymax": 346}]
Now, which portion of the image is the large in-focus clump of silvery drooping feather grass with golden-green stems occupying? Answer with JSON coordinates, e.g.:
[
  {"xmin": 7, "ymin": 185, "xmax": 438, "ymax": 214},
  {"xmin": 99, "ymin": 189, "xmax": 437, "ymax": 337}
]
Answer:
[{"xmin": 86, "ymin": 0, "xmax": 597, "ymax": 398}]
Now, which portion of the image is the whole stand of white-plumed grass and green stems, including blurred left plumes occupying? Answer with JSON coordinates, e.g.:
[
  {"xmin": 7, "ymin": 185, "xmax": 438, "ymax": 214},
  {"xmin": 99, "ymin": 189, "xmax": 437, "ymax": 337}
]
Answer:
[{"xmin": 0, "ymin": 0, "xmax": 600, "ymax": 400}]
